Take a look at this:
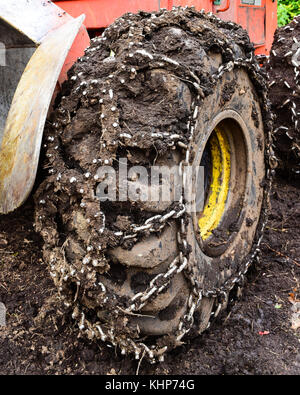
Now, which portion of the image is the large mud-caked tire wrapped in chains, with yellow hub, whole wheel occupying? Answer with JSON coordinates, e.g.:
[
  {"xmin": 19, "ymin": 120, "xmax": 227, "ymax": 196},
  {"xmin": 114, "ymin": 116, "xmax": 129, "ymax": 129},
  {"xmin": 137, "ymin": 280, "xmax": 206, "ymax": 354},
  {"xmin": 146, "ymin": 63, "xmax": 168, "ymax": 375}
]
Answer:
[{"xmin": 35, "ymin": 8, "xmax": 272, "ymax": 361}]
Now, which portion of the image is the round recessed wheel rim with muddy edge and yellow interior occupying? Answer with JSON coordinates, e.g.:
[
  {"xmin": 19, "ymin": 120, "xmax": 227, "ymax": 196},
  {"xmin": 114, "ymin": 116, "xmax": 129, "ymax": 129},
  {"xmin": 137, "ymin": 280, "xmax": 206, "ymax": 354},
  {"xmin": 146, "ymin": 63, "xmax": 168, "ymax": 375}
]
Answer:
[{"xmin": 195, "ymin": 111, "xmax": 251, "ymax": 256}]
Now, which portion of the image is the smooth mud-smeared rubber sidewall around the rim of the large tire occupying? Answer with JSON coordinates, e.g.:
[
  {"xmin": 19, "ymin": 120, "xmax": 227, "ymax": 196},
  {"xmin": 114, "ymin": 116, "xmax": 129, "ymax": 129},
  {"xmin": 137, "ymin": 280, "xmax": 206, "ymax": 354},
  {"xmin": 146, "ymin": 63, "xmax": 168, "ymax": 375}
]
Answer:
[{"xmin": 187, "ymin": 69, "xmax": 265, "ymax": 289}]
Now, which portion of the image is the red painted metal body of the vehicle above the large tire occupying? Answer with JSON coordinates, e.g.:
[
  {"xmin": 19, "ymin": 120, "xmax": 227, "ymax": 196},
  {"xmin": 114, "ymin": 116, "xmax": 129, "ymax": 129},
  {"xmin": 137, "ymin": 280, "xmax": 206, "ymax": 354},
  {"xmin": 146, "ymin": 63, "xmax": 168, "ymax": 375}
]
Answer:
[{"xmin": 56, "ymin": 0, "xmax": 277, "ymax": 54}]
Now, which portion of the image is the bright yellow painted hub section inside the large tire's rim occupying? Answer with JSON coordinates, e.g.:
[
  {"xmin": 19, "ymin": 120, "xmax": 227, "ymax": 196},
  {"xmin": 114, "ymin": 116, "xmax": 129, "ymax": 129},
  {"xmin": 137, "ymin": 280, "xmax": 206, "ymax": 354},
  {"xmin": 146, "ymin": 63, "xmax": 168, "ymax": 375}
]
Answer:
[{"xmin": 198, "ymin": 127, "xmax": 231, "ymax": 240}]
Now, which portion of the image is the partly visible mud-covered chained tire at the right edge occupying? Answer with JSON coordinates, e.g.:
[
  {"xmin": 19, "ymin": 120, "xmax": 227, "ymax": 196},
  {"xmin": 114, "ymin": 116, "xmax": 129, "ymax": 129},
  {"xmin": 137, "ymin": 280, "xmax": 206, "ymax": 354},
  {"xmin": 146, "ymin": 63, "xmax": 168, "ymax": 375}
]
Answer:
[{"xmin": 267, "ymin": 16, "xmax": 300, "ymax": 178}]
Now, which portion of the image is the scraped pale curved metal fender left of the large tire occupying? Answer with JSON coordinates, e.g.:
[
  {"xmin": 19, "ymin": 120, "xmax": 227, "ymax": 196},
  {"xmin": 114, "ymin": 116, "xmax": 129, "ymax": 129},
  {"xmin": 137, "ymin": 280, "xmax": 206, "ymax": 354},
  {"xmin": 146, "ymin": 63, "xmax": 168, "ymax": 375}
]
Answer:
[{"xmin": 0, "ymin": 0, "xmax": 85, "ymax": 214}]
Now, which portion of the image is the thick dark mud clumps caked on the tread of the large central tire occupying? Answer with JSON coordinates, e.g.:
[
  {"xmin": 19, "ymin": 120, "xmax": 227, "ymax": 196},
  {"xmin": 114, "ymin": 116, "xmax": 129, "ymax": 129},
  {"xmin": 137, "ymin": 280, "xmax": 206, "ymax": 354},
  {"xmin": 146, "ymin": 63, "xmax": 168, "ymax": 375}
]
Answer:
[{"xmin": 35, "ymin": 8, "xmax": 272, "ymax": 361}]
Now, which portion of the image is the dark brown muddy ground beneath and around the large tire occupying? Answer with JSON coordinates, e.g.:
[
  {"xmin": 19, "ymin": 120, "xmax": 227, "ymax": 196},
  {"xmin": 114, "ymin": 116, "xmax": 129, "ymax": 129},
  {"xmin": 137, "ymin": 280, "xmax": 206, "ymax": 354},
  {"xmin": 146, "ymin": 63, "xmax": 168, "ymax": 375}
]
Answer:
[{"xmin": 0, "ymin": 179, "xmax": 300, "ymax": 375}]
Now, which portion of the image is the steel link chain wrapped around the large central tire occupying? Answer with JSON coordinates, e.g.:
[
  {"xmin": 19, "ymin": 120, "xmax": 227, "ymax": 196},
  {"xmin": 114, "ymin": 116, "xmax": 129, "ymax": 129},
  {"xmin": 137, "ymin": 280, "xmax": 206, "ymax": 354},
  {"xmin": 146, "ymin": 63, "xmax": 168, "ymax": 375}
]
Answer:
[{"xmin": 37, "ymin": 7, "xmax": 277, "ymax": 363}]
